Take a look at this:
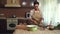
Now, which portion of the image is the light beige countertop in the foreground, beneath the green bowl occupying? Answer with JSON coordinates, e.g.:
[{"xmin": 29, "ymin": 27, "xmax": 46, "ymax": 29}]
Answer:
[{"xmin": 13, "ymin": 29, "xmax": 60, "ymax": 34}]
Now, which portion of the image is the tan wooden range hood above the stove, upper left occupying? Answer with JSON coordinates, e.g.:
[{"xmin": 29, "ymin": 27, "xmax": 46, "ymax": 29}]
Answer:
[{"xmin": 5, "ymin": 0, "xmax": 21, "ymax": 7}]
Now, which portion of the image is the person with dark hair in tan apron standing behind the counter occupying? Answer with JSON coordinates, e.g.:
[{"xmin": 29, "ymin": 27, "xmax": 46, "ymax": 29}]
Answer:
[{"xmin": 30, "ymin": 1, "xmax": 43, "ymax": 25}]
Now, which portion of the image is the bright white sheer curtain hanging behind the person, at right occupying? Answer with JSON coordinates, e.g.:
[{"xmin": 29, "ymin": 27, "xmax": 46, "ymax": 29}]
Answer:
[{"xmin": 37, "ymin": 0, "xmax": 60, "ymax": 26}]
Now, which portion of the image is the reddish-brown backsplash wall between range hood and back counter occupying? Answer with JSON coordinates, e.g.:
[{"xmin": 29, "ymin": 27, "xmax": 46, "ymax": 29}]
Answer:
[{"xmin": 0, "ymin": 8, "xmax": 32, "ymax": 17}]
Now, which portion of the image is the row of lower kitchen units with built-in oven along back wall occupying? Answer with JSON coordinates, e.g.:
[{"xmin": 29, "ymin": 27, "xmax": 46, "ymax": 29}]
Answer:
[{"xmin": 0, "ymin": 18, "xmax": 30, "ymax": 33}]
